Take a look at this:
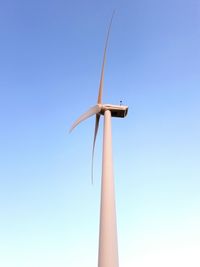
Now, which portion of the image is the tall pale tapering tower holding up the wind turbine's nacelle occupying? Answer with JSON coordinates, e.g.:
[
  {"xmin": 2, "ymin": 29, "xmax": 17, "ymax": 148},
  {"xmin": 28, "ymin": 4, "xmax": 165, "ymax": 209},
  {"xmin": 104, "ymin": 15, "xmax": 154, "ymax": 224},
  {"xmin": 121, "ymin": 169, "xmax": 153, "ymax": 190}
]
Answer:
[{"xmin": 98, "ymin": 110, "xmax": 119, "ymax": 267}]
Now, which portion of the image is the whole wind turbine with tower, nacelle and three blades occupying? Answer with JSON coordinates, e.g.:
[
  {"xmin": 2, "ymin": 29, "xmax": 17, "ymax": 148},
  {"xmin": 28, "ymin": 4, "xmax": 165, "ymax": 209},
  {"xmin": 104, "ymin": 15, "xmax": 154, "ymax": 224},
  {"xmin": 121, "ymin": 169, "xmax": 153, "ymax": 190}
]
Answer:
[{"xmin": 70, "ymin": 13, "xmax": 128, "ymax": 267}]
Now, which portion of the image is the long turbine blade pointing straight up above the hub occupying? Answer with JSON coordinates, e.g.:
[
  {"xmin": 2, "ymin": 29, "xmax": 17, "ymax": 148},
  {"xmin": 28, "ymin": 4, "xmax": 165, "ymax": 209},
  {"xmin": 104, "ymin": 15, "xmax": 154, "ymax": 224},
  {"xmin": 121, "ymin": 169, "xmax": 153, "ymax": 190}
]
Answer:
[{"xmin": 97, "ymin": 10, "xmax": 115, "ymax": 104}]
